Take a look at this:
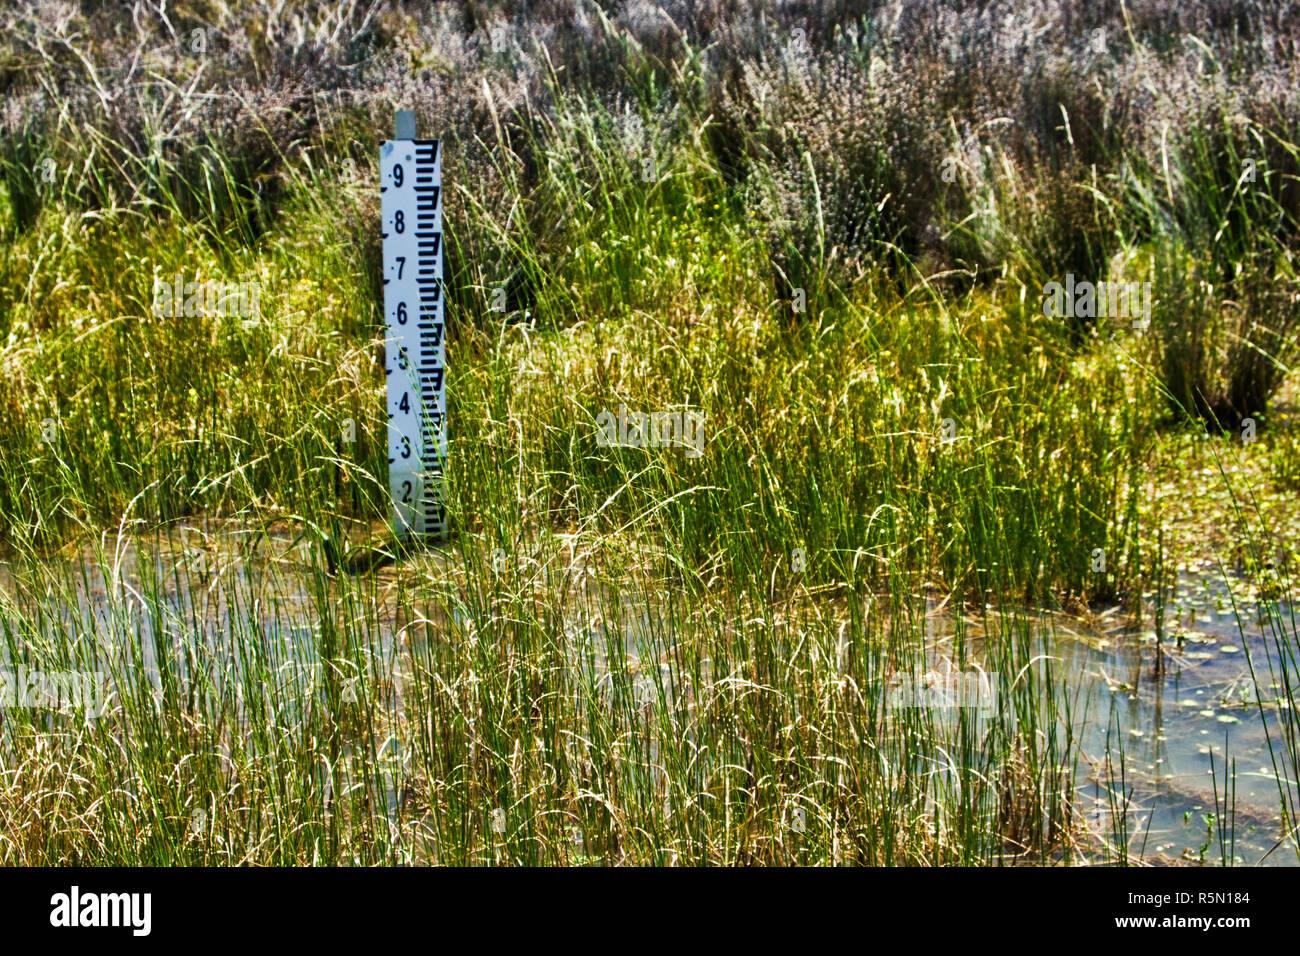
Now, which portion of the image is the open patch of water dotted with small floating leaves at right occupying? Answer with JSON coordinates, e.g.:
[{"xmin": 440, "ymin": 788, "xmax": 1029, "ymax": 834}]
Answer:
[{"xmin": 1044, "ymin": 576, "xmax": 1300, "ymax": 865}]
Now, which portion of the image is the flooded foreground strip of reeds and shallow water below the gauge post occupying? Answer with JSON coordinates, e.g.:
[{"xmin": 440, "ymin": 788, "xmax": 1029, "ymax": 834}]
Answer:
[{"xmin": 0, "ymin": 509, "xmax": 1300, "ymax": 865}]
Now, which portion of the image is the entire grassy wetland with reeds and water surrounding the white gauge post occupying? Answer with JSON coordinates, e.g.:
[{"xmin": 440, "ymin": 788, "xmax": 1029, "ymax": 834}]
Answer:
[{"xmin": 0, "ymin": 0, "xmax": 1300, "ymax": 866}]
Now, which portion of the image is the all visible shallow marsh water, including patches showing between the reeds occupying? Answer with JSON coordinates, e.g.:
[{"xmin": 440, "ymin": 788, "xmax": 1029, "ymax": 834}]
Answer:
[{"xmin": 0, "ymin": 535, "xmax": 1300, "ymax": 865}]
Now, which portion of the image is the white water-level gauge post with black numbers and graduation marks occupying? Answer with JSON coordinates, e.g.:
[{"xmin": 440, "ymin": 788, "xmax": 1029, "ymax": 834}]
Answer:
[{"xmin": 380, "ymin": 111, "xmax": 447, "ymax": 540}]
